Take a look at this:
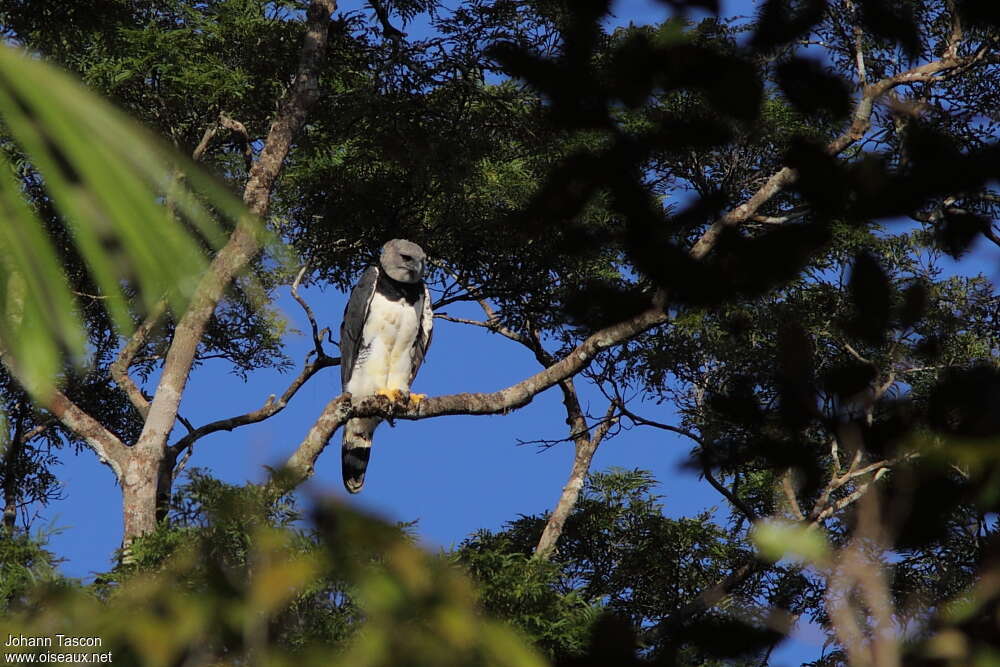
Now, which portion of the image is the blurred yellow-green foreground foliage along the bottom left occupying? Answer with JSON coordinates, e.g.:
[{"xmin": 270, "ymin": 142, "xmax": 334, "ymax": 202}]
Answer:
[{"xmin": 0, "ymin": 471, "xmax": 545, "ymax": 667}]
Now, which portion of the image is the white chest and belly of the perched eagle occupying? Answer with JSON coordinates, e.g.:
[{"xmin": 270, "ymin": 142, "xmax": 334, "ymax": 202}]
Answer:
[{"xmin": 346, "ymin": 292, "xmax": 420, "ymax": 396}]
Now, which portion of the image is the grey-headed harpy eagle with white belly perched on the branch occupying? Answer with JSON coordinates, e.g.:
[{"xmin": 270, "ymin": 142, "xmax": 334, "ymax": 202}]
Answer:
[{"xmin": 340, "ymin": 239, "xmax": 434, "ymax": 493}]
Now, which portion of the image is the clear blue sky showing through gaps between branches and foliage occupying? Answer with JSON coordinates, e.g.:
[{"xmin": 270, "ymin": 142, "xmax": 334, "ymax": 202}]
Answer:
[{"xmin": 31, "ymin": 0, "xmax": 992, "ymax": 664}]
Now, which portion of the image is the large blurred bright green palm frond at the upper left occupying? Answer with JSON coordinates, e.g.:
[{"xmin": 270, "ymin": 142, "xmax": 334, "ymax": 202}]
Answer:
[{"xmin": 0, "ymin": 41, "xmax": 260, "ymax": 392}]
